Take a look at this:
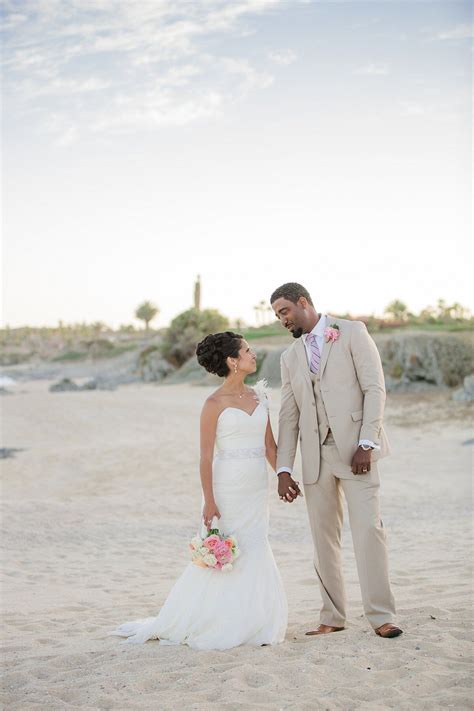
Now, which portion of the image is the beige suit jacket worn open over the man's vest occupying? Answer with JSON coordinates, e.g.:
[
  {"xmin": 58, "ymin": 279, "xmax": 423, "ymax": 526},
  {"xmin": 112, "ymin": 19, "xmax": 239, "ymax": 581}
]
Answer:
[{"xmin": 277, "ymin": 316, "xmax": 390, "ymax": 484}]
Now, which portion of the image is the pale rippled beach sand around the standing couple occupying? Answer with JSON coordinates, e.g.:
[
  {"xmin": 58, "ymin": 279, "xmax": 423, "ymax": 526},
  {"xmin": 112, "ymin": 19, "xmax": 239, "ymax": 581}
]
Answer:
[{"xmin": 1, "ymin": 381, "xmax": 472, "ymax": 711}]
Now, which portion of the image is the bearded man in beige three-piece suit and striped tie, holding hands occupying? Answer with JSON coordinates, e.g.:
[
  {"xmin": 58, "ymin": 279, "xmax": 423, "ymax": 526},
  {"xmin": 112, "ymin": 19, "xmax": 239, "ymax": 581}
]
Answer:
[{"xmin": 270, "ymin": 283, "xmax": 402, "ymax": 637}]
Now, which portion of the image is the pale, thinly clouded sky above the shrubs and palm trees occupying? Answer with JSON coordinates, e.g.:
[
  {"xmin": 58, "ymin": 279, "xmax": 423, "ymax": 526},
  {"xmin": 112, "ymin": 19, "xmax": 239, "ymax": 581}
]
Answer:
[{"xmin": 2, "ymin": 0, "xmax": 474, "ymax": 327}]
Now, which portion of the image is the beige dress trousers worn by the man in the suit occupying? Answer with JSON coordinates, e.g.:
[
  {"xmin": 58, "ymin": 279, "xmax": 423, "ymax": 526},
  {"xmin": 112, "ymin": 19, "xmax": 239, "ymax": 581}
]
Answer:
[{"xmin": 304, "ymin": 435, "xmax": 395, "ymax": 629}]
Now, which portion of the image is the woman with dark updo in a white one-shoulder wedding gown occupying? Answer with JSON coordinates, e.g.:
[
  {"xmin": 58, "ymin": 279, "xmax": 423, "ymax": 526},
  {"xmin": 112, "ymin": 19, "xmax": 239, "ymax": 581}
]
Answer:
[{"xmin": 111, "ymin": 331, "xmax": 288, "ymax": 649}]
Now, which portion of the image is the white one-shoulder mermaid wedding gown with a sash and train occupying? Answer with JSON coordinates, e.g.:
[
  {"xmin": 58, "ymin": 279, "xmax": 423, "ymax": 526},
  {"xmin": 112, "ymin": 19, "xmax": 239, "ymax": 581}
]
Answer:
[{"xmin": 111, "ymin": 390, "xmax": 288, "ymax": 649}]
